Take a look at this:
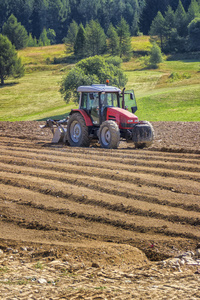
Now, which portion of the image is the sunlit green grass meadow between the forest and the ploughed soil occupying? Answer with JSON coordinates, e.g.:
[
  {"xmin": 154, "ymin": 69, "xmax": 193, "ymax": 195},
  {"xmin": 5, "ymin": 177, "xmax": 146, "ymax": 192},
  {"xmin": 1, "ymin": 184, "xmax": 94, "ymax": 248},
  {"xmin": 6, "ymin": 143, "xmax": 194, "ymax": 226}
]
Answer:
[{"xmin": 0, "ymin": 37, "xmax": 200, "ymax": 121}]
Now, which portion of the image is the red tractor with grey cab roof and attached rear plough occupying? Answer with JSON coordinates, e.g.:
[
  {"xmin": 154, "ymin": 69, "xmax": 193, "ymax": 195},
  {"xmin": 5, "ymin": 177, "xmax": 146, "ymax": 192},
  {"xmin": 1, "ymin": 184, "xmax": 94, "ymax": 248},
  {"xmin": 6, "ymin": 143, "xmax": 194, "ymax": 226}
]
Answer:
[{"xmin": 42, "ymin": 84, "xmax": 154, "ymax": 149}]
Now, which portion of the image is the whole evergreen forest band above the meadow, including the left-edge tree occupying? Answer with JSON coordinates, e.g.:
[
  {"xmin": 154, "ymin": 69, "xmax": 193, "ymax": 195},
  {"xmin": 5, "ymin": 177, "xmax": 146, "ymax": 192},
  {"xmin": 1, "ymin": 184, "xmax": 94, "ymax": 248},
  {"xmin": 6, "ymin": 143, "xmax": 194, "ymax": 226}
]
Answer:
[{"xmin": 0, "ymin": 0, "xmax": 200, "ymax": 85}]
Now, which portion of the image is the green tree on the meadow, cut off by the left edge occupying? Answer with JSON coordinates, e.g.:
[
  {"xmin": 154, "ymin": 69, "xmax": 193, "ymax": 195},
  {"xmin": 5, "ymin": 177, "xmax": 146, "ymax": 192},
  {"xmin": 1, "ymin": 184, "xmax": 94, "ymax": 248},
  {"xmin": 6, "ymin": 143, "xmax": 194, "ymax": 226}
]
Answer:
[{"xmin": 0, "ymin": 34, "xmax": 24, "ymax": 85}]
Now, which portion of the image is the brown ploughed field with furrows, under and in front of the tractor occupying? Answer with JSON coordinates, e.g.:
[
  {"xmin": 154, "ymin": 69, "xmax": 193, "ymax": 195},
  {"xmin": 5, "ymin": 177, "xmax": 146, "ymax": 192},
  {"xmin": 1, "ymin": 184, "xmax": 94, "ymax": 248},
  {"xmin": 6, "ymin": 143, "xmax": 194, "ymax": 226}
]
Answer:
[{"xmin": 0, "ymin": 122, "xmax": 200, "ymax": 299}]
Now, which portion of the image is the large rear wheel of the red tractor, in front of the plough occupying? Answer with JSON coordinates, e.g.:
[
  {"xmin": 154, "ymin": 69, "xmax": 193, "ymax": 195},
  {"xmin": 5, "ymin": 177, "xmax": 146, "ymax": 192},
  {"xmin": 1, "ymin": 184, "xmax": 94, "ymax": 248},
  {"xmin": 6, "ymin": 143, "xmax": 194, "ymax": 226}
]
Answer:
[{"xmin": 67, "ymin": 113, "xmax": 90, "ymax": 147}]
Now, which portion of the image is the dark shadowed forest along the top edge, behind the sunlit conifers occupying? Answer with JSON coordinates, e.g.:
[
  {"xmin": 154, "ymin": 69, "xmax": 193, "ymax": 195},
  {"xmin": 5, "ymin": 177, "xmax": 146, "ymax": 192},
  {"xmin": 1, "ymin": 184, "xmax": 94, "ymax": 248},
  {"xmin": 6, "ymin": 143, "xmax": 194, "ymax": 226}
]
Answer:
[{"xmin": 0, "ymin": 0, "xmax": 199, "ymax": 43}]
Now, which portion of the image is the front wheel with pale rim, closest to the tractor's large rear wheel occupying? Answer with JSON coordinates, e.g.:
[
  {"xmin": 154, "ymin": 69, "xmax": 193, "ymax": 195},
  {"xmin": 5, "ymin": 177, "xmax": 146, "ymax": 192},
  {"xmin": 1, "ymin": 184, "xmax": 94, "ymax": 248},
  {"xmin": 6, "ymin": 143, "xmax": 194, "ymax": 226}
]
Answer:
[{"xmin": 99, "ymin": 121, "xmax": 120, "ymax": 149}]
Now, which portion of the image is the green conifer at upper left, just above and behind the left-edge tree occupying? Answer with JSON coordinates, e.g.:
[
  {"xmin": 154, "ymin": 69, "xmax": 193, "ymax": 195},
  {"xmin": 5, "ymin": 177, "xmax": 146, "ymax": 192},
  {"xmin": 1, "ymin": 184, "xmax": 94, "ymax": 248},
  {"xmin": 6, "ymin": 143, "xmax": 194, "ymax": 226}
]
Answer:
[{"xmin": 2, "ymin": 15, "xmax": 28, "ymax": 49}]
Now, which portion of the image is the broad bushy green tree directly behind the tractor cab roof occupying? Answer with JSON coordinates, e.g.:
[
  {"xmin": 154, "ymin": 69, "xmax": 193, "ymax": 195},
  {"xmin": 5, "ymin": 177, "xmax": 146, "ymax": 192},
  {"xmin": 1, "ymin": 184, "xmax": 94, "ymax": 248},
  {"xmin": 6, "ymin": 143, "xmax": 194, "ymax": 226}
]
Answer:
[{"xmin": 60, "ymin": 55, "xmax": 128, "ymax": 103}]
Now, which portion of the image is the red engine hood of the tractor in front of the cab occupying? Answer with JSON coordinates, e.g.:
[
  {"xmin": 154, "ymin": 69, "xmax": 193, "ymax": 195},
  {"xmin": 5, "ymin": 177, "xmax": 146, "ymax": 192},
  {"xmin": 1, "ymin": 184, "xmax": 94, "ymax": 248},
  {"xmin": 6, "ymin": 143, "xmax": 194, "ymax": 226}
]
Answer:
[{"xmin": 106, "ymin": 107, "xmax": 139, "ymax": 129}]
